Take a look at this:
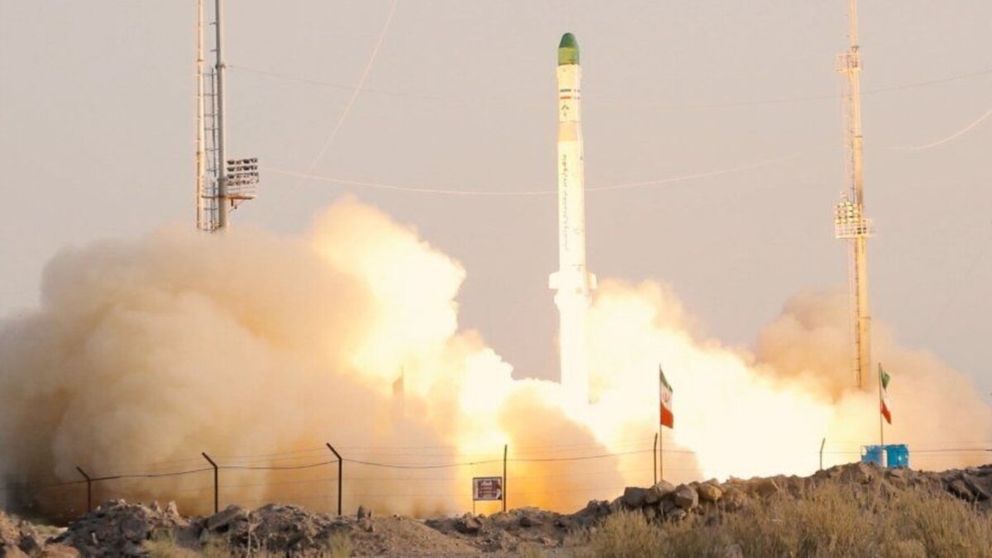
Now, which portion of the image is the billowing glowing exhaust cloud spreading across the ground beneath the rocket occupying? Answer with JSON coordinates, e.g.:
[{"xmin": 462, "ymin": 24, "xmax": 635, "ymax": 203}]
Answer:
[{"xmin": 0, "ymin": 198, "xmax": 992, "ymax": 516}]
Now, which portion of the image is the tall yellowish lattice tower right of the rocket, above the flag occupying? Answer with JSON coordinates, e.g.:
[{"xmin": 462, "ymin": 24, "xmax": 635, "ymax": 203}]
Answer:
[{"xmin": 834, "ymin": 0, "xmax": 872, "ymax": 387}]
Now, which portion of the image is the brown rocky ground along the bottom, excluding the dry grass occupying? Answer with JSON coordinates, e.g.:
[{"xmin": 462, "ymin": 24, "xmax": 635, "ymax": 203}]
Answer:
[{"xmin": 0, "ymin": 464, "xmax": 992, "ymax": 558}]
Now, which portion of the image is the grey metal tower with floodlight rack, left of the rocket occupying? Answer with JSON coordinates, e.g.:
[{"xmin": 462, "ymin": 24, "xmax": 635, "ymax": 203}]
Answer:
[{"xmin": 195, "ymin": 0, "xmax": 259, "ymax": 232}]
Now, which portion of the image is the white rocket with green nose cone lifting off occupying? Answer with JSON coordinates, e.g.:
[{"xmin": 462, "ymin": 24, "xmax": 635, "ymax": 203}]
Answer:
[{"xmin": 548, "ymin": 33, "xmax": 596, "ymax": 403}]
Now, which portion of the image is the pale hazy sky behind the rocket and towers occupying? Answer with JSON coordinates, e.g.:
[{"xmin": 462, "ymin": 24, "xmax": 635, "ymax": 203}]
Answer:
[{"xmin": 0, "ymin": 0, "xmax": 992, "ymax": 393}]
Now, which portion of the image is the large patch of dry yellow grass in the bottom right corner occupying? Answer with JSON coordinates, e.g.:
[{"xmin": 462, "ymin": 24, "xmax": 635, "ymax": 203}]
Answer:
[{"xmin": 589, "ymin": 486, "xmax": 992, "ymax": 558}]
